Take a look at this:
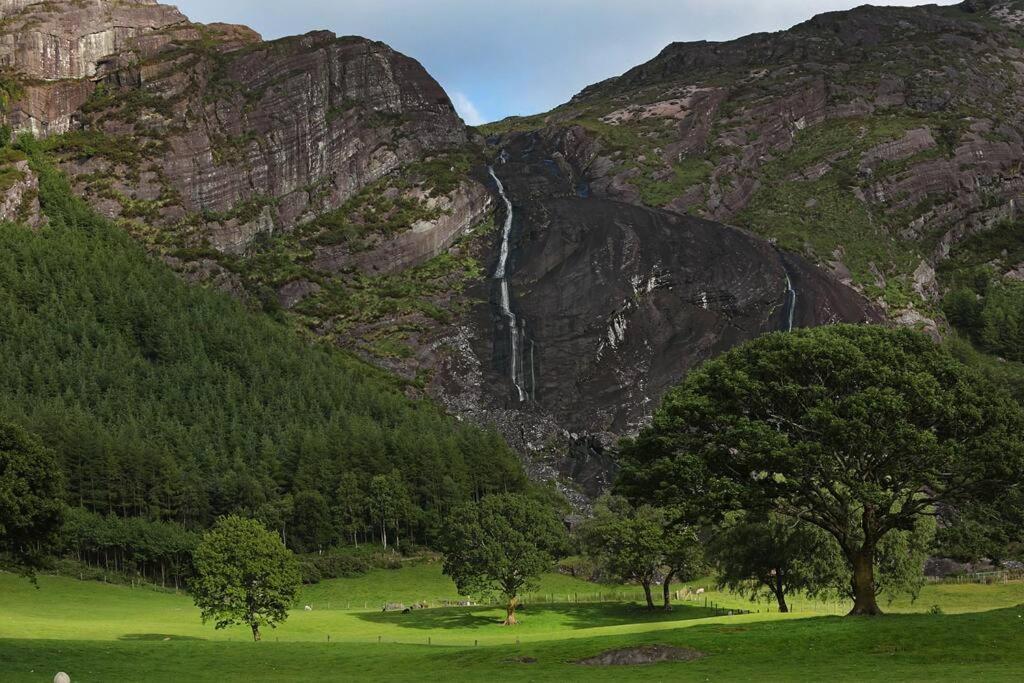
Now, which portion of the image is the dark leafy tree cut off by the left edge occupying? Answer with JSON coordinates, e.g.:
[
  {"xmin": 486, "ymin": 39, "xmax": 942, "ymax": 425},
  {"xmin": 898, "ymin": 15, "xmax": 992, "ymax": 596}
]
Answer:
[{"xmin": 0, "ymin": 422, "xmax": 65, "ymax": 577}]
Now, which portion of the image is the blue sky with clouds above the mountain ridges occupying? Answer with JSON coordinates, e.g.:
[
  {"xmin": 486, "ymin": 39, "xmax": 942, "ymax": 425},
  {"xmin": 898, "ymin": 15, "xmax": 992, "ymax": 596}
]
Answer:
[{"xmin": 174, "ymin": 0, "xmax": 957, "ymax": 124}]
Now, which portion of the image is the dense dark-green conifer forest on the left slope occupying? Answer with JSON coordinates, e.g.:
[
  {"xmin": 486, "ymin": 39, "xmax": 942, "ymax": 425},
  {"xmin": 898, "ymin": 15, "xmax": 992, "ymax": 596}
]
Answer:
[{"xmin": 0, "ymin": 140, "xmax": 526, "ymax": 575}]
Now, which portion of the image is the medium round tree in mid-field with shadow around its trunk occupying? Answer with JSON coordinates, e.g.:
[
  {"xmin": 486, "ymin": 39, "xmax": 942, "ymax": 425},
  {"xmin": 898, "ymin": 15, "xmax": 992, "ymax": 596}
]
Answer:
[{"xmin": 443, "ymin": 494, "xmax": 566, "ymax": 626}]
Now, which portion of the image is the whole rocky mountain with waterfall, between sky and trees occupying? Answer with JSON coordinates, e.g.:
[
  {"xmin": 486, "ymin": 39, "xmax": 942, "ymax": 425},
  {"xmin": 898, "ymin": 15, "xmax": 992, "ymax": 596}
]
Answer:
[{"xmin": 9, "ymin": 0, "xmax": 1024, "ymax": 505}]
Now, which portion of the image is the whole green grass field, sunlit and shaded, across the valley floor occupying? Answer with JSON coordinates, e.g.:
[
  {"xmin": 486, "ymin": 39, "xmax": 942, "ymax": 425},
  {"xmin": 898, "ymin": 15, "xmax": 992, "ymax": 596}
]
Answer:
[{"xmin": 0, "ymin": 564, "xmax": 1024, "ymax": 681}]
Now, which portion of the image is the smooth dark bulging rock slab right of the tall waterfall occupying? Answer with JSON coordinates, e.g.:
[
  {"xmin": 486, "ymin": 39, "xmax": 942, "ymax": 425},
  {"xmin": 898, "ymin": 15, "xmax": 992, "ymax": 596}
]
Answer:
[{"xmin": 495, "ymin": 193, "xmax": 870, "ymax": 433}]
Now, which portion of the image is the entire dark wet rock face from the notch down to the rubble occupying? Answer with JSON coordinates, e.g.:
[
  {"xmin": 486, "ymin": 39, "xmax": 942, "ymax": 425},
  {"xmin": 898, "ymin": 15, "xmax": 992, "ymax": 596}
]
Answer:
[{"xmin": 435, "ymin": 134, "xmax": 882, "ymax": 496}]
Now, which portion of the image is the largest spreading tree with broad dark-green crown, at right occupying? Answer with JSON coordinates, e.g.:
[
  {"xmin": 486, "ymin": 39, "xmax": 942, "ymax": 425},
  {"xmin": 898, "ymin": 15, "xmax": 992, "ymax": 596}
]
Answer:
[{"xmin": 623, "ymin": 326, "xmax": 1024, "ymax": 614}]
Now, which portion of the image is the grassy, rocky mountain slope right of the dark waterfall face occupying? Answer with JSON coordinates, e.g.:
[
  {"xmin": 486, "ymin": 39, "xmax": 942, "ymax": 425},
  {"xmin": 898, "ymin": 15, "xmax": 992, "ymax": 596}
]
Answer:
[{"xmin": 485, "ymin": 1, "xmax": 1024, "ymax": 331}]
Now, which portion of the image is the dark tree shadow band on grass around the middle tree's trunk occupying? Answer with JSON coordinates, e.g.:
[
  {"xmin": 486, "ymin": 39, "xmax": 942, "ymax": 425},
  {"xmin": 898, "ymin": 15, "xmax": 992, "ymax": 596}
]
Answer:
[{"xmin": 357, "ymin": 602, "xmax": 715, "ymax": 631}]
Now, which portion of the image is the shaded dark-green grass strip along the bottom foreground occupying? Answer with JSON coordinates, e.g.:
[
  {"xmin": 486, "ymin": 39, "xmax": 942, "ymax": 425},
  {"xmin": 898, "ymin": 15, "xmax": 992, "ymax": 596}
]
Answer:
[{"xmin": 0, "ymin": 609, "xmax": 1024, "ymax": 681}]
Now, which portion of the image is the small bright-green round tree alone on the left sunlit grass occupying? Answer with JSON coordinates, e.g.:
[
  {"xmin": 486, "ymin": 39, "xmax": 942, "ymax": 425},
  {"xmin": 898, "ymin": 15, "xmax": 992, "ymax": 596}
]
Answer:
[{"xmin": 190, "ymin": 516, "xmax": 301, "ymax": 641}]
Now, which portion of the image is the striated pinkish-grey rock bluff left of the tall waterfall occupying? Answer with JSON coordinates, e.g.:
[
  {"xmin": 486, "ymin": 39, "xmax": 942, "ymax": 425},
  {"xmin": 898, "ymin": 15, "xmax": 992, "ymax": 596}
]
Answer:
[{"xmin": 0, "ymin": 0, "xmax": 471, "ymax": 270}]
